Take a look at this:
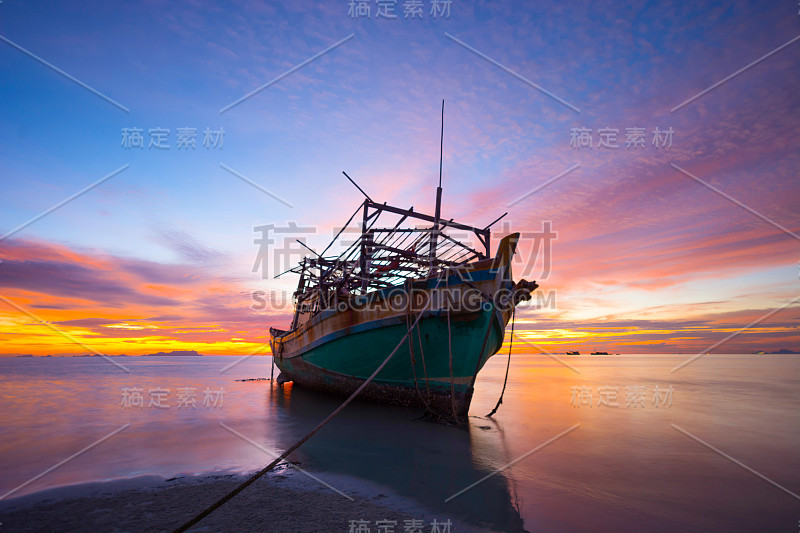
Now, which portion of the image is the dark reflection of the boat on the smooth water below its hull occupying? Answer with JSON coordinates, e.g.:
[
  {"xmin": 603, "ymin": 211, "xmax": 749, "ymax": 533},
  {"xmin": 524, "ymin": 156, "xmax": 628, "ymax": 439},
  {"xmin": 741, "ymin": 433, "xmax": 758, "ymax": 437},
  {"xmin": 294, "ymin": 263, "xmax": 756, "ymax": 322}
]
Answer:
[{"xmin": 270, "ymin": 384, "xmax": 525, "ymax": 531}]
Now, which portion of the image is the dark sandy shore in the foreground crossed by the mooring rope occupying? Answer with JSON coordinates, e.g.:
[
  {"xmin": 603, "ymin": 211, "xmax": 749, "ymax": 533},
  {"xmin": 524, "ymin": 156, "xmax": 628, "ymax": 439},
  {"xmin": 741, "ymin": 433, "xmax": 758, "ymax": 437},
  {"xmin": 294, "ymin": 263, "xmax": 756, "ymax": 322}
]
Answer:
[{"xmin": 0, "ymin": 465, "xmax": 492, "ymax": 533}]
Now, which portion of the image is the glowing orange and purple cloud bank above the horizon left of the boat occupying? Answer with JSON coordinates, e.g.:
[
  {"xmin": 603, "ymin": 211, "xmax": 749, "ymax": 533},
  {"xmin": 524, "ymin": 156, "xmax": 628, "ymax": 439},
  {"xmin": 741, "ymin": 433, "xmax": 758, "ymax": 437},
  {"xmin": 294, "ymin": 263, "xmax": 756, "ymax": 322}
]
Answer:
[{"xmin": 0, "ymin": 236, "xmax": 285, "ymax": 355}]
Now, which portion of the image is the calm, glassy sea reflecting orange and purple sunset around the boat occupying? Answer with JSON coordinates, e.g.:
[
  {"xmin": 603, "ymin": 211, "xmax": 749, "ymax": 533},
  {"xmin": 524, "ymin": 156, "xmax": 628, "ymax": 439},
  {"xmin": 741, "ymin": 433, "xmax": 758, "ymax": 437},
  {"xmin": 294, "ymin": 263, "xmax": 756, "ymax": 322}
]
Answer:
[{"xmin": 0, "ymin": 354, "xmax": 800, "ymax": 532}]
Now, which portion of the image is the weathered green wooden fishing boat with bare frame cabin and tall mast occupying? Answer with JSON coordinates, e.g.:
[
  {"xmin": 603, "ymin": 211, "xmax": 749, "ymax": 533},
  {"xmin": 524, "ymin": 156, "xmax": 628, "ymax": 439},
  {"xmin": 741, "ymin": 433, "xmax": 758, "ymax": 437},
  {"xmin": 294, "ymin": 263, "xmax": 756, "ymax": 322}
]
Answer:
[{"xmin": 270, "ymin": 107, "xmax": 538, "ymax": 419}]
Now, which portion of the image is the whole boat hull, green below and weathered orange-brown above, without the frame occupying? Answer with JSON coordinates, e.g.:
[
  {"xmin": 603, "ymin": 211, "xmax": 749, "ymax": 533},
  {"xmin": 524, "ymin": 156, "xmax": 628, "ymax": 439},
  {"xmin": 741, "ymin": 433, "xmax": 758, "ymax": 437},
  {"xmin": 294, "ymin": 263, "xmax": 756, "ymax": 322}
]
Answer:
[{"xmin": 270, "ymin": 238, "xmax": 516, "ymax": 417}]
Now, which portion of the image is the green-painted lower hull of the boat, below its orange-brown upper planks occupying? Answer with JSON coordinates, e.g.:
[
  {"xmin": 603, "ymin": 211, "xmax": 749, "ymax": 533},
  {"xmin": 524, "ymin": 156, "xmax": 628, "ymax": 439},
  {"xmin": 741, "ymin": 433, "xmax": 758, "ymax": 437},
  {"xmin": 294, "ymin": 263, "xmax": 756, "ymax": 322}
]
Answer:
[{"xmin": 276, "ymin": 309, "xmax": 506, "ymax": 416}]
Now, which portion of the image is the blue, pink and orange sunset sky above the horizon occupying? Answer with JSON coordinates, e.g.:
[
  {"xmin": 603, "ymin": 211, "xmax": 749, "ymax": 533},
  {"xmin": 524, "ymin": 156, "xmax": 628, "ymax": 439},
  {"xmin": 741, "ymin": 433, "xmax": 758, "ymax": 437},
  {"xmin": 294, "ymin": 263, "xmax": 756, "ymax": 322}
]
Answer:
[{"xmin": 0, "ymin": 0, "xmax": 800, "ymax": 355}]
